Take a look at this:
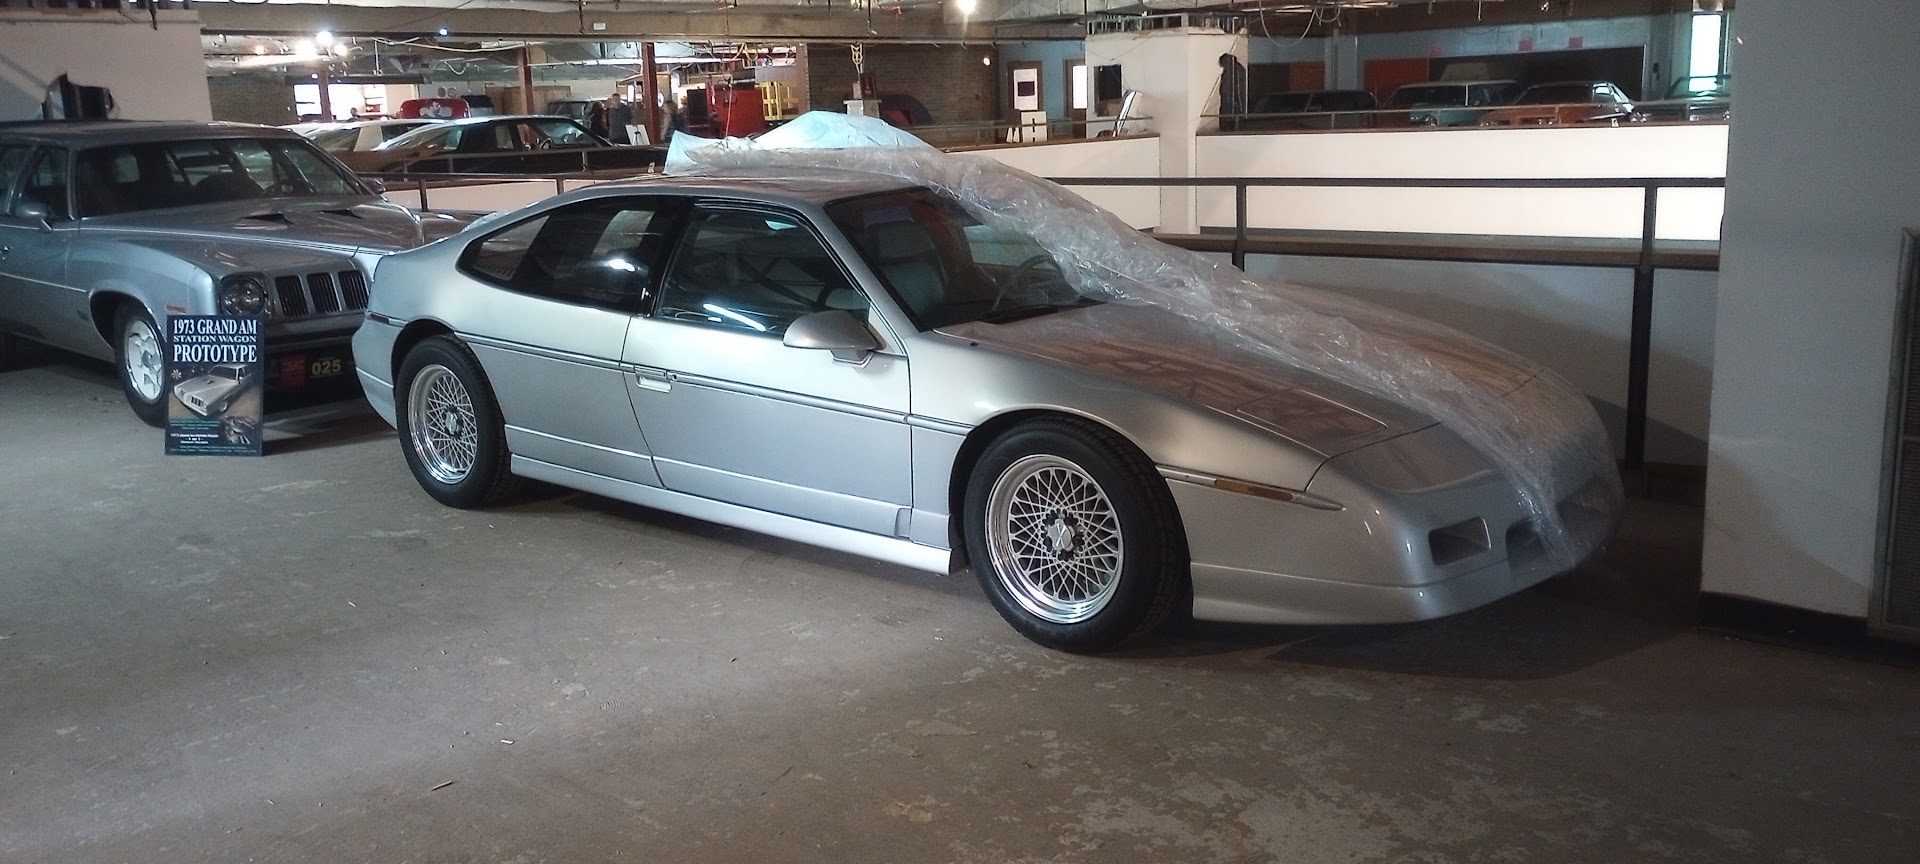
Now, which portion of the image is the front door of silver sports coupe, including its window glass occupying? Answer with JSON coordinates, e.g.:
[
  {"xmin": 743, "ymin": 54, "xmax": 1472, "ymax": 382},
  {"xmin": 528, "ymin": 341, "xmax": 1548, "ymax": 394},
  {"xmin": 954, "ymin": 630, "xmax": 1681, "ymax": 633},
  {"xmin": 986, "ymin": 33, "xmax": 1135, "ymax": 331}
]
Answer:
[{"xmin": 624, "ymin": 202, "xmax": 912, "ymax": 536}]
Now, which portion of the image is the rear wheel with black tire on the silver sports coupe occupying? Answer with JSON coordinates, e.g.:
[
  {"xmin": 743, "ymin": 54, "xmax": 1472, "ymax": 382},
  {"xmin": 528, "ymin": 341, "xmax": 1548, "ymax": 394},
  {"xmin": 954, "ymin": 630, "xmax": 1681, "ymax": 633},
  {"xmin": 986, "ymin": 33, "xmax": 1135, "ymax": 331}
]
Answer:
[{"xmin": 394, "ymin": 336, "xmax": 518, "ymax": 509}]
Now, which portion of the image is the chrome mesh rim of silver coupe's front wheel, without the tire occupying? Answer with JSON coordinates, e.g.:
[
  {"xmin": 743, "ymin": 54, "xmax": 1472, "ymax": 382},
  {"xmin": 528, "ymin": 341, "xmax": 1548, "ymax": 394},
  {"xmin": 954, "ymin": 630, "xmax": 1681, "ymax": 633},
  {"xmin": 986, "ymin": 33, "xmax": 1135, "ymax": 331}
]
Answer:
[{"xmin": 987, "ymin": 453, "xmax": 1125, "ymax": 624}]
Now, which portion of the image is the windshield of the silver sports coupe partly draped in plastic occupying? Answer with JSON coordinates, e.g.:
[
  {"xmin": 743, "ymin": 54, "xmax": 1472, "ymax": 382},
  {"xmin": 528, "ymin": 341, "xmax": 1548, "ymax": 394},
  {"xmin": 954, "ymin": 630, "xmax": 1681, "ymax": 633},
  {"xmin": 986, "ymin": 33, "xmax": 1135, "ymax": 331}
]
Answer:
[{"xmin": 828, "ymin": 188, "xmax": 1096, "ymax": 330}]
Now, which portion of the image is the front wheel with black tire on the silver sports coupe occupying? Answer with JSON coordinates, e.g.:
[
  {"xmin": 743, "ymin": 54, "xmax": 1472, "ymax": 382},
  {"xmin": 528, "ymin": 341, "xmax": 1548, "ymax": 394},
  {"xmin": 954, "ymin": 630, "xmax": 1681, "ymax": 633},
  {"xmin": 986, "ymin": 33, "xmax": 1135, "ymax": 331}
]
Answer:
[{"xmin": 962, "ymin": 419, "xmax": 1188, "ymax": 653}]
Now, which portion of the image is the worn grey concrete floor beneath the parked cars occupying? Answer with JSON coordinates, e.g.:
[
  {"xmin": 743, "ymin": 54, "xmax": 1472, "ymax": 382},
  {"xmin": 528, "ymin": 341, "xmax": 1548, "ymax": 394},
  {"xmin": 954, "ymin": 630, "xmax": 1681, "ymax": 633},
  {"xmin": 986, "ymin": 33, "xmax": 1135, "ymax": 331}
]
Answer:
[{"xmin": 0, "ymin": 357, "xmax": 1920, "ymax": 864}]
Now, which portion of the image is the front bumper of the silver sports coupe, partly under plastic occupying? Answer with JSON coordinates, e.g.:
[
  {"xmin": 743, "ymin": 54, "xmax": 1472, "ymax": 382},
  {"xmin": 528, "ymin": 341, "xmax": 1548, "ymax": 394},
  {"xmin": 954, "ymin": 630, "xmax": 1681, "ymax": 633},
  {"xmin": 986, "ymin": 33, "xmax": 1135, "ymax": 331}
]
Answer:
[{"xmin": 1167, "ymin": 426, "xmax": 1620, "ymax": 624}]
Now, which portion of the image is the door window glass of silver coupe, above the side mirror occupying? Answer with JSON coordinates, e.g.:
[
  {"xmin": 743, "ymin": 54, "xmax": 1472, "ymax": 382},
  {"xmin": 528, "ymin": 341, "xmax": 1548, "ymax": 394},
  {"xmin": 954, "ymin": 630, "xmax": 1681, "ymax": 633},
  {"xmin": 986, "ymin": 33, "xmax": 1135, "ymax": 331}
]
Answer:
[{"xmin": 655, "ymin": 207, "xmax": 868, "ymax": 334}]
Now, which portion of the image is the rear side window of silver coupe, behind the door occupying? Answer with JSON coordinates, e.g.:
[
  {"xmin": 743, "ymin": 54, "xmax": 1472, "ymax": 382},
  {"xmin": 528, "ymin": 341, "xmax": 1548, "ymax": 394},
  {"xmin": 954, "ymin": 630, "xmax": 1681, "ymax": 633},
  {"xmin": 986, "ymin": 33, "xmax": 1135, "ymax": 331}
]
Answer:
[{"xmin": 459, "ymin": 198, "xmax": 676, "ymax": 311}]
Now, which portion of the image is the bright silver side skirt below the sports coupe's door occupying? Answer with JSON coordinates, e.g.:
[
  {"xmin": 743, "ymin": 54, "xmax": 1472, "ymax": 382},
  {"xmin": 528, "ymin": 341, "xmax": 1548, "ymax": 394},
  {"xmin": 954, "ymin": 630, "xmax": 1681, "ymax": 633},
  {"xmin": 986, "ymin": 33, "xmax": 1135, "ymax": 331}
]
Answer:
[{"xmin": 513, "ymin": 455, "xmax": 952, "ymax": 572}]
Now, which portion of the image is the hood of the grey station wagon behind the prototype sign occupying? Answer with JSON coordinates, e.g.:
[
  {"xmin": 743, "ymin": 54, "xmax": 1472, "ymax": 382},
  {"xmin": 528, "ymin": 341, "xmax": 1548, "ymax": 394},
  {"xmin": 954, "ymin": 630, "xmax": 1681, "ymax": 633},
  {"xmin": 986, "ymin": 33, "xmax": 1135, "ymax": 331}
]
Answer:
[{"xmin": 86, "ymin": 196, "xmax": 439, "ymax": 252}]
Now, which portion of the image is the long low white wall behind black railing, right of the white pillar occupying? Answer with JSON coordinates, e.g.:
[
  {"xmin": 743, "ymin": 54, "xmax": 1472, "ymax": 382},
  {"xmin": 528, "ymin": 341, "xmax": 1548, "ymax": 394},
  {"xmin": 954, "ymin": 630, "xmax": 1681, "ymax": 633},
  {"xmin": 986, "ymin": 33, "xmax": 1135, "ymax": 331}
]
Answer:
[{"xmin": 1198, "ymin": 123, "xmax": 1728, "ymax": 240}]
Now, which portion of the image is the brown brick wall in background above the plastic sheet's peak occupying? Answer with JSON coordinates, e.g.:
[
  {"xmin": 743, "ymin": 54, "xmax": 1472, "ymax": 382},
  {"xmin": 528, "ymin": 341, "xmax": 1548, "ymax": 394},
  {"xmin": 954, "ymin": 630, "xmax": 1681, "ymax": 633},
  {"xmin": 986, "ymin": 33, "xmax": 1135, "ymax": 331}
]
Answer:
[{"xmin": 804, "ymin": 42, "xmax": 1000, "ymax": 125}]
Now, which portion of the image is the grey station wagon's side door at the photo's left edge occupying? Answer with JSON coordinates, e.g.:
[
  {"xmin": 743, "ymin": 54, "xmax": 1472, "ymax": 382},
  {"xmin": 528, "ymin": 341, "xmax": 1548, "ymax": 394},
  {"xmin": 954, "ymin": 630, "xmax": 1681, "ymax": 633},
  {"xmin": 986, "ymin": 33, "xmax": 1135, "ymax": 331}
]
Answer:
[{"xmin": 0, "ymin": 148, "xmax": 90, "ymax": 357}]
